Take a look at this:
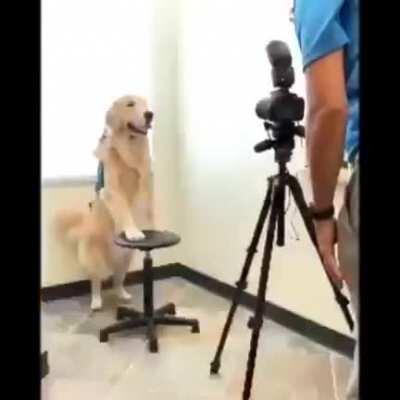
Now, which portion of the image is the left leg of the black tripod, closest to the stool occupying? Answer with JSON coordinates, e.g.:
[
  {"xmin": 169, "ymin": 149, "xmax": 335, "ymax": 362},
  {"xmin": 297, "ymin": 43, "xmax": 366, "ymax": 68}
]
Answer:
[{"xmin": 210, "ymin": 177, "xmax": 274, "ymax": 374}]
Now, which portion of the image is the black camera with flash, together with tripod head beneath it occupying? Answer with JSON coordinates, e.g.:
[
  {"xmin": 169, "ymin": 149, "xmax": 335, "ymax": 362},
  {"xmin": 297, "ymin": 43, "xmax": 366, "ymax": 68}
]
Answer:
[{"xmin": 254, "ymin": 40, "xmax": 304, "ymax": 166}]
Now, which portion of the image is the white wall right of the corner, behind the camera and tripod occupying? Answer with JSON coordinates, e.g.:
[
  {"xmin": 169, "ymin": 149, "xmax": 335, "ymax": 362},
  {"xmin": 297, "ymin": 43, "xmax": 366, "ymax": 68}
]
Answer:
[{"xmin": 179, "ymin": 0, "xmax": 348, "ymax": 333}]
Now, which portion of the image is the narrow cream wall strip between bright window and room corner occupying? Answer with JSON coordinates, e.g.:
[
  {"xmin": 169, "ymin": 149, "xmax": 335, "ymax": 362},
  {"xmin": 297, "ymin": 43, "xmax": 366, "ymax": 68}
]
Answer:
[{"xmin": 151, "ymin": 0, "xmax": 184, "ymax": 261}]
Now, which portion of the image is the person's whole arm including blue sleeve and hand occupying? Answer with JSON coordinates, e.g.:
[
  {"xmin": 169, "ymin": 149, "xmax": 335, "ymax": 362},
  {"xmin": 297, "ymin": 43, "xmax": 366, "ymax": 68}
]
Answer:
[{"xmin": 294, "ymin": 0, "xmax": 349, "ymax": 285}]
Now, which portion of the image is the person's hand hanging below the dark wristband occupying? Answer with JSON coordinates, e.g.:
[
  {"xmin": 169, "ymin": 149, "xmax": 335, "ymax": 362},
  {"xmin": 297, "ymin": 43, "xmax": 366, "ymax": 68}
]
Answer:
[{"xmin": 314, "ymin": 218, "xmax": 343, "ymax": 288}]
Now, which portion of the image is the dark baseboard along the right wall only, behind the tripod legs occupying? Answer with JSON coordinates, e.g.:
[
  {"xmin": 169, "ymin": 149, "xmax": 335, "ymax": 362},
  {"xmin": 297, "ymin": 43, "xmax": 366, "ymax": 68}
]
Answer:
[{"xmin": 180, "ymin": 265, "xmax": 355, "ymax": 358}]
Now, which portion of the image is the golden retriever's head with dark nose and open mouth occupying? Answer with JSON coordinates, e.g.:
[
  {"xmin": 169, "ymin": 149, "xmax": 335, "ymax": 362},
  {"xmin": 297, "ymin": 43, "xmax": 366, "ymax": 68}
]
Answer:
[{"xmin": 106, "ymin": 96, "xmax": 153, "ymax": 138}]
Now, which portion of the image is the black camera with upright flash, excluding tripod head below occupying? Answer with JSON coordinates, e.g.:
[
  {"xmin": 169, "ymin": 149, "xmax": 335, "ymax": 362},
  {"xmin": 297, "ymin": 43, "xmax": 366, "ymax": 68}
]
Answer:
[{"xmin": 255, "ymin": 40, "xmax": 305, "ymax": 142}]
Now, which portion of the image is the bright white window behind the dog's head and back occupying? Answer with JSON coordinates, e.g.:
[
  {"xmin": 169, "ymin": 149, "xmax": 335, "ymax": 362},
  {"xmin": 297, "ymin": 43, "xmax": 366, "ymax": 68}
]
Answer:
[{"xmin": 41, "ymin": 0, "xmax": 151, "ymax": 179}]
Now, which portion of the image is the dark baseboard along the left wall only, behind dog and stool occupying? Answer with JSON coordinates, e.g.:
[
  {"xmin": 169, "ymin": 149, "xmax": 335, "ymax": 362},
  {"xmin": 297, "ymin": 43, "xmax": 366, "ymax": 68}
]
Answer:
[{"xmin": 41, "ymin": 264, "xmax": 180, "ymax": 302}]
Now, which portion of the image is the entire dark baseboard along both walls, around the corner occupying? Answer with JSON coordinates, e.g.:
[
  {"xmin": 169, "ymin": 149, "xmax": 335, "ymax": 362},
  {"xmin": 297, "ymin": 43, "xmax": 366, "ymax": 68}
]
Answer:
[{"xmin": 41, "ymin": 263, "xmax": 355, "ymax": 358}]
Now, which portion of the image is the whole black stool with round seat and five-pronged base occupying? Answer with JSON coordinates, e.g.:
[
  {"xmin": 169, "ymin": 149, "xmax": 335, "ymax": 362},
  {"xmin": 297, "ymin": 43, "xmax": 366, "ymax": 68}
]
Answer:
[{"xmin": 100, "ymin": 230, "xmax": 200, "ymax": 353}]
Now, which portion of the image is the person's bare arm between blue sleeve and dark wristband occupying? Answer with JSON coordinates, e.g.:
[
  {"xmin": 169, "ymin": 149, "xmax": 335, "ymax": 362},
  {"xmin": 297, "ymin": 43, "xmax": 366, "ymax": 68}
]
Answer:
[{"xmin": 305, "ymin": 49, "xmax": 347, "ymax": 210}]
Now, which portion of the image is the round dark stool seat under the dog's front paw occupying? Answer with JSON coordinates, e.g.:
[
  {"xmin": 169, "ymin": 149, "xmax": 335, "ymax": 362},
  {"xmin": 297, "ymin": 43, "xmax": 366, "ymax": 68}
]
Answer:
[{"xmin": 114, "ymin": 230, "xmax": 181, "ymax": 251}]
